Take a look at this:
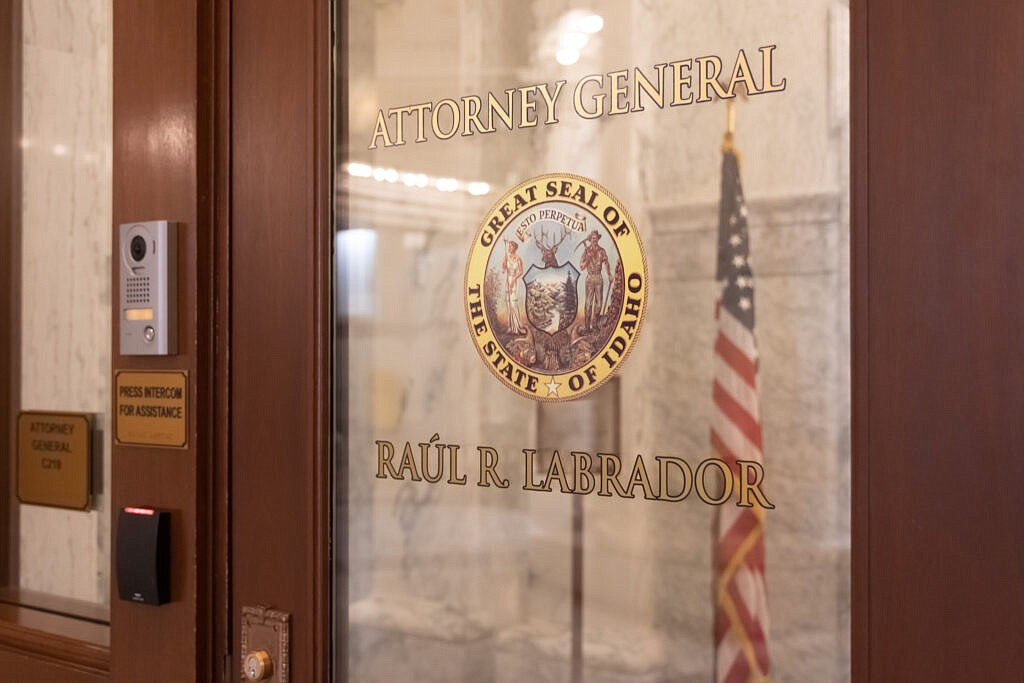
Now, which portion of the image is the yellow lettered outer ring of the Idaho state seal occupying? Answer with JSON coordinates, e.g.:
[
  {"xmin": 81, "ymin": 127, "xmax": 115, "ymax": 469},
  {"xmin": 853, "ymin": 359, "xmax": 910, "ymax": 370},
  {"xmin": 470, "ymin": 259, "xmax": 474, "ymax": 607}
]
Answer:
[{"xmin": 463, "ymin": 172, "xmax": 650, "ymax": 402}]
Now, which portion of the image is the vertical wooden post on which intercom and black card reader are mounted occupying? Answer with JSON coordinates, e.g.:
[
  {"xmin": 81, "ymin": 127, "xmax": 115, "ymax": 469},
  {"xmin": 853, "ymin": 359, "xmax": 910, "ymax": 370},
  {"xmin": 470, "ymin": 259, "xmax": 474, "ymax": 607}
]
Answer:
[{"xmin": 111, "ymin": 0, "xmax": 228, "ymax": 683}]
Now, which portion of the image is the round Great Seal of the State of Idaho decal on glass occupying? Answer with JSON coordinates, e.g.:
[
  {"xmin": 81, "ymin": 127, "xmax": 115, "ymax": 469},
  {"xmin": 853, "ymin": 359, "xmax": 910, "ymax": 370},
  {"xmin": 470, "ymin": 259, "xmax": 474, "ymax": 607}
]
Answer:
[{"xmin": 465, "ymin": 173, "xmax": 647, "ymax": 400}]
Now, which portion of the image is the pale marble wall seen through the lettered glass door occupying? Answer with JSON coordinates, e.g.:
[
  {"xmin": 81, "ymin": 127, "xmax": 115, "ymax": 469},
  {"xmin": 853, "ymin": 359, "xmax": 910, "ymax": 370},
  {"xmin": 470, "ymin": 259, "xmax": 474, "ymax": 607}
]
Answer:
[{"xmin": 339, "ymin": 0, "xmax": 850, "ymax": 683}]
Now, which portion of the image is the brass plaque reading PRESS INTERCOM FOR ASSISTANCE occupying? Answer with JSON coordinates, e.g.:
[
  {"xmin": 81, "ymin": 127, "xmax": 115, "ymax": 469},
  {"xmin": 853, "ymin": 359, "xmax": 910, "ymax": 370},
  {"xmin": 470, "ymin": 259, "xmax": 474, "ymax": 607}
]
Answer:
[{"xmin": 114, "ymin": 370, "xmax": 188, "ymax": 449}]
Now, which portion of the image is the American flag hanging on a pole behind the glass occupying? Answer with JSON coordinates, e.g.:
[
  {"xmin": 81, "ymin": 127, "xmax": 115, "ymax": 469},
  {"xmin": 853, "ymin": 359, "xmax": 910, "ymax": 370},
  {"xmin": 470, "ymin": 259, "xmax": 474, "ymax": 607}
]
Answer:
[{"xmin": 711, "ymin": 137, "xmax": 771, "ymax": 683}]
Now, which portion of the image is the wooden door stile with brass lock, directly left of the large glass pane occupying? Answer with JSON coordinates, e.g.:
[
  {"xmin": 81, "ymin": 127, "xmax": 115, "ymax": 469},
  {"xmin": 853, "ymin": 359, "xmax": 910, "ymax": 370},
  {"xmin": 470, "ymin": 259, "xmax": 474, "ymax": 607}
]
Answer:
[{"xmin": 231, "ymin": 0, "xmax": 334, "ymax": 681}]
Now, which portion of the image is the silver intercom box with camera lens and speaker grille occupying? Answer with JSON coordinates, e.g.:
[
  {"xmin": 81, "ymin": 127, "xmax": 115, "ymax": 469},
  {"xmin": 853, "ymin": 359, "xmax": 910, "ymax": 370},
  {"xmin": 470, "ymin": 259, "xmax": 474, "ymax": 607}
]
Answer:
[{"xmin": 119, "ymin": 220, "xmax": 178, "ymax": 355}]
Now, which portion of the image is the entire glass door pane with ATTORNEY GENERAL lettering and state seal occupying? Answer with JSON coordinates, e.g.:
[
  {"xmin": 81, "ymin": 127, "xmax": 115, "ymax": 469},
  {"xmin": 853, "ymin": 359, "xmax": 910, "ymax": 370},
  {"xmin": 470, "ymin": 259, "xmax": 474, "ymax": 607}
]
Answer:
[{"xmin": 335, "ymin": 0, "xmax": 850, "ymax": 683}]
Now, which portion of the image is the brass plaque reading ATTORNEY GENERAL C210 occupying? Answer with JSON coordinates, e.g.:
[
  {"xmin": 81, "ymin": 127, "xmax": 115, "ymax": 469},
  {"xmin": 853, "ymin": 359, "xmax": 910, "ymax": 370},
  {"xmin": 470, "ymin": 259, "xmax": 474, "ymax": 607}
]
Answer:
[{"xmin": 17, "ymin": 411, "xmax": 92, "ymax": 510}]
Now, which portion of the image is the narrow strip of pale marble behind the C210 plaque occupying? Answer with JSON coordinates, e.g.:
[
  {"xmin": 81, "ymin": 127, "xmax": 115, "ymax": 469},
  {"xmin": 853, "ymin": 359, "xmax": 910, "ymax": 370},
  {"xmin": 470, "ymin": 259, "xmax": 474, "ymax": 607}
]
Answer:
[{"xmin": 19, "ymin": 0, "xmax": 112, "ymax": 604}]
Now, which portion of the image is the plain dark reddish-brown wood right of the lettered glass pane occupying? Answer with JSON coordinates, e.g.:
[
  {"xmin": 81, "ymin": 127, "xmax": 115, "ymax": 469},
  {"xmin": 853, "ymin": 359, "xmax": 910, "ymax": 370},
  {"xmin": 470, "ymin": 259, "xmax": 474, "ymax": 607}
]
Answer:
[{"xmin": 854, "ymin": 0, "xmax": 1024, "ymax": 682}]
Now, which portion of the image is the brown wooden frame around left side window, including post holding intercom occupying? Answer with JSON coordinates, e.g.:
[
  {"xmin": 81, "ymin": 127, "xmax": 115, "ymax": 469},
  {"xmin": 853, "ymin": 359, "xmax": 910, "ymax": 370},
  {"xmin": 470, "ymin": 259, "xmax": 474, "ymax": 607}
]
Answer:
[{"xmin": 0, "ymin": 0, "xmax": 237, "ymax": 683}]
